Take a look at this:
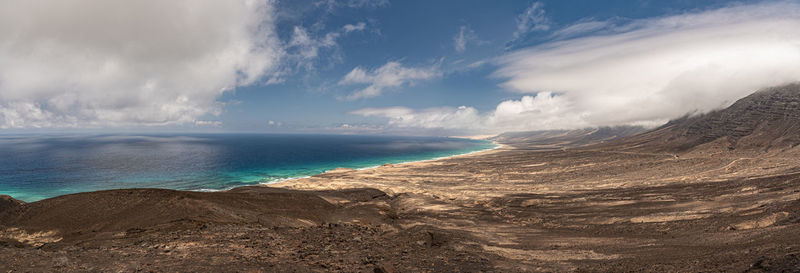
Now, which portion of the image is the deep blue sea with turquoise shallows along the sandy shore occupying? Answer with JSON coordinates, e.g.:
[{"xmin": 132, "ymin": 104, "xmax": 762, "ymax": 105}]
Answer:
[{"xmin": 0, "ymin": 134, "xmax": 494, "ymax": 202}]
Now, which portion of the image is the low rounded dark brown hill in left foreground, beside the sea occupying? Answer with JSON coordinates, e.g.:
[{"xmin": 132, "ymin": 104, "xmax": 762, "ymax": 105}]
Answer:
[{"xmin": 0, "ymin": 187, "xmax": 386, "ymax": 241}]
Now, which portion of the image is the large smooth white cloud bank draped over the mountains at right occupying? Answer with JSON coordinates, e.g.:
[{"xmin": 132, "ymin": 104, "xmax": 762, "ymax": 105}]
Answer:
[{"xmin": 353, "ymin": 2, "xmax": 800, "ymax": 132}]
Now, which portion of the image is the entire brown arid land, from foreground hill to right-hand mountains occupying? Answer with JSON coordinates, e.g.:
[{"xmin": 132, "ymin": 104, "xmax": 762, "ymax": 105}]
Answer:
[{"xmin": 0, "ymin": 84, "xmax": 800, "ymax": 272}]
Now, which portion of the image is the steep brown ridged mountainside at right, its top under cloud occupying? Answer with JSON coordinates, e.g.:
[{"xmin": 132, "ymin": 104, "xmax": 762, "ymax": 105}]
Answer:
[{"xmin": 607, "ymin": 83, "xmax": 800, "ymax": 153}]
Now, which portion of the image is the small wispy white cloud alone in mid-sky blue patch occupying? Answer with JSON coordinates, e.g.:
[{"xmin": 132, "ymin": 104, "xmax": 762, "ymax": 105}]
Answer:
[{"xmin": 339, "ymin": 61, "xmax": 442, "ymax": 100}]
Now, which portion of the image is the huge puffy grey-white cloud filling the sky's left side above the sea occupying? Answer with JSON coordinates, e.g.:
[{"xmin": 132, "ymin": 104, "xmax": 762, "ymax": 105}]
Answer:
[{"xmin": 0, "ymin": 0, "xmax": 282, "ymax": 128}]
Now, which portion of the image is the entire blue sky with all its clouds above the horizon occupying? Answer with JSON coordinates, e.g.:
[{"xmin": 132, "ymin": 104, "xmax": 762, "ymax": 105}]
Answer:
[{"xmin": 0, "ymin": 0, "xmax": 800, "ymax": 136}]
